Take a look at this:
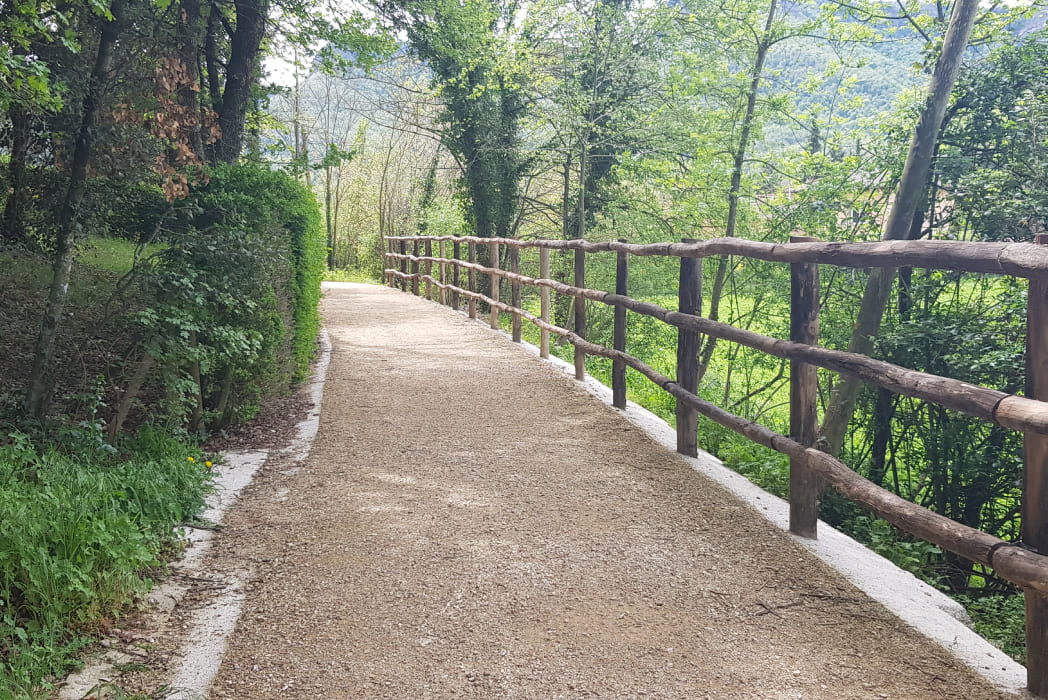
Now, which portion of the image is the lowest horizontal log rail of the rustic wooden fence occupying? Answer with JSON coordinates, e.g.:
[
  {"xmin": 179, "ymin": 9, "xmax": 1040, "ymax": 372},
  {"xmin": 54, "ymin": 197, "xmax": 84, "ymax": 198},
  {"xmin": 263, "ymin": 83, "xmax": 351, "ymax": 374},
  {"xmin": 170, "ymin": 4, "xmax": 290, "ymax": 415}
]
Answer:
[{"xmin": 391, "ymin": 265, "xmax": 1048, "ymax": 592}]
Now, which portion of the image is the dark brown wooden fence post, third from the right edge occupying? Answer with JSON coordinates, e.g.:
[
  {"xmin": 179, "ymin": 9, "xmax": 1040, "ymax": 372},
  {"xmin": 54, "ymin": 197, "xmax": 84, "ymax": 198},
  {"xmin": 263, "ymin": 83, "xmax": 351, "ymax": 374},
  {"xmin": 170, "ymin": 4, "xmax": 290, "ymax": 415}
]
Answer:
[{"xmin": 677, "ymin": 238, "xmax": 702, "ymax": 457}]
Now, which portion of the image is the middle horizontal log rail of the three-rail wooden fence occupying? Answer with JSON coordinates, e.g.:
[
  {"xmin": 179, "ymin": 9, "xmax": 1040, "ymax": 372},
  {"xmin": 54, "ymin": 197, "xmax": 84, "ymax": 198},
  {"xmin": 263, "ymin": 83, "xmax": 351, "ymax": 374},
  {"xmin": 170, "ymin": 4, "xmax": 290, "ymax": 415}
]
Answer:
[{"xmin": 393, "ymin": 250, "xmax": 1048, "ymax": 435}]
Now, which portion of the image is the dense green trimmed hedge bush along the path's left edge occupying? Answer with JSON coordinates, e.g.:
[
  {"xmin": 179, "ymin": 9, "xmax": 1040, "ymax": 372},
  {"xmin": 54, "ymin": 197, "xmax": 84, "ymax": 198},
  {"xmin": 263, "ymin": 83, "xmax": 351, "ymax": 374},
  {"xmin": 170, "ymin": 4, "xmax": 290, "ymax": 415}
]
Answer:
[{"xmin": 124, "ymin": 165, "xmax": 325, "ymax": 432}]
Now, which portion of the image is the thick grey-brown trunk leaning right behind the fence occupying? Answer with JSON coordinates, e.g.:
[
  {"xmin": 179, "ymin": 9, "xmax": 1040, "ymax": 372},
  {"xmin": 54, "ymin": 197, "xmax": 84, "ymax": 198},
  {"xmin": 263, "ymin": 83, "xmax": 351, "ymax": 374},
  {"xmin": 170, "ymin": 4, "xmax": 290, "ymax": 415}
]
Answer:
[{"xmin": 818, "ymin": 0, "xmax": 979, "ymax": 455}]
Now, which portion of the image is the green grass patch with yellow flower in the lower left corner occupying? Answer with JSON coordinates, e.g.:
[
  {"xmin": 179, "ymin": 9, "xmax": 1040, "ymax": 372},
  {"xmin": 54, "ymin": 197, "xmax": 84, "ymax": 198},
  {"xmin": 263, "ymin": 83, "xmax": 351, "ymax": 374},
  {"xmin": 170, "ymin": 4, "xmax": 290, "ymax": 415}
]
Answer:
[{"xmin": 0, "ymin": 428, "xmax": 211, "ymax": 698}]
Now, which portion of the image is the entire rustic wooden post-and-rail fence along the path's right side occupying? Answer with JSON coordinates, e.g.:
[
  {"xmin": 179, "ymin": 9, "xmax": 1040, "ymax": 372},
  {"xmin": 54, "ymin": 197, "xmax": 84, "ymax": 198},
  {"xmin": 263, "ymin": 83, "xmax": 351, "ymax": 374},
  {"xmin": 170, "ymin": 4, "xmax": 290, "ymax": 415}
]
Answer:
[{"xmin": 385, "ymin": 236, "xmax": 1048, "ymax": 697}]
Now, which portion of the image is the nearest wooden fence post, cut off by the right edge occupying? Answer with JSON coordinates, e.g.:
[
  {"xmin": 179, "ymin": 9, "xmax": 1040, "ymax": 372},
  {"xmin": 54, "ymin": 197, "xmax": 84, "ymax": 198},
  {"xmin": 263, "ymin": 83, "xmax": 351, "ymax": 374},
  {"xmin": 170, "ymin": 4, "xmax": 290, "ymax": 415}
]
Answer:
[{"xmin": 1023, "ymin": 234, "xmax": 1048, "ymax": 697}]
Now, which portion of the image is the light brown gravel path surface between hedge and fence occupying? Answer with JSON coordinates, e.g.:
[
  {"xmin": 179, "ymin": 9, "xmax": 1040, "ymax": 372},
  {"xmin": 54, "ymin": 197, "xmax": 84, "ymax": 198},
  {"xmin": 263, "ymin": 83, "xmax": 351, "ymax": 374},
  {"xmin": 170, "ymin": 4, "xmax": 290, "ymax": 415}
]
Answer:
[{"xmin": 169, "ymin": 286, "xmax": 1010, "ymax": 700}]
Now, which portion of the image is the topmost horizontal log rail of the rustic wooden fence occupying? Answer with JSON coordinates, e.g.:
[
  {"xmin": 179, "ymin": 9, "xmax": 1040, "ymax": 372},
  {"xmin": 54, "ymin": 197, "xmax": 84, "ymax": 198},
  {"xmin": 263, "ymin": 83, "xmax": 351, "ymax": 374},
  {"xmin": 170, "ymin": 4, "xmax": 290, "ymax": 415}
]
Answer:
[{"xmin": 390, "ymin": 236, "xmax": 1048, "ymax": 279}]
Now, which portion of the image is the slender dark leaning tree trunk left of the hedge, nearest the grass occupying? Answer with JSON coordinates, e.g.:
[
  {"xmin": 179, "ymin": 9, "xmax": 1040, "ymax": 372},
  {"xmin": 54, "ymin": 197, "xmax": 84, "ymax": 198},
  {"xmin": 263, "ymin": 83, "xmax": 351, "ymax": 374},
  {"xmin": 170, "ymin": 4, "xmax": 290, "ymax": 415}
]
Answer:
[{"xmin": 25, "ymin": 0, "xmax": 127, "ymax": 418}]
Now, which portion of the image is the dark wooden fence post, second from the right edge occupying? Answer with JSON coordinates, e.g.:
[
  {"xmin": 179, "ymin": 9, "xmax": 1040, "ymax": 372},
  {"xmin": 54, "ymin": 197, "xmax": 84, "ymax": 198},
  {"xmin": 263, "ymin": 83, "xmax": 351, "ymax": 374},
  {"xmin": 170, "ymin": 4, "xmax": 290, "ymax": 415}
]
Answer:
[{"xmin": 789, "ymin": 236, "xmax": 822, "ymax": 540}]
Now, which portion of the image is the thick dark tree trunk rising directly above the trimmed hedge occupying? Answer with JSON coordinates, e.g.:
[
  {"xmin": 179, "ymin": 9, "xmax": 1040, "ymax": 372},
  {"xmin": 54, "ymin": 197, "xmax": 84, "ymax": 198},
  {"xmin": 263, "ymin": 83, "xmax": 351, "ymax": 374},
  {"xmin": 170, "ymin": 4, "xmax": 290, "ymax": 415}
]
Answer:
[{"xmin": 213, "ymin": 0, "xmax": 269, "ymax": 162}]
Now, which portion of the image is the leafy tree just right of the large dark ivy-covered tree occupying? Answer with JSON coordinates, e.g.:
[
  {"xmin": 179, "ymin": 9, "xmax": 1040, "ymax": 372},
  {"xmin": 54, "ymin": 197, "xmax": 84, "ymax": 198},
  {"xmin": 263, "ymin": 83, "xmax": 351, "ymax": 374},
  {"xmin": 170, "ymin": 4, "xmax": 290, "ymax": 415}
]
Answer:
[{"xmin": 524, "ymin": 0, "xmax": 672, "ymax": 238}]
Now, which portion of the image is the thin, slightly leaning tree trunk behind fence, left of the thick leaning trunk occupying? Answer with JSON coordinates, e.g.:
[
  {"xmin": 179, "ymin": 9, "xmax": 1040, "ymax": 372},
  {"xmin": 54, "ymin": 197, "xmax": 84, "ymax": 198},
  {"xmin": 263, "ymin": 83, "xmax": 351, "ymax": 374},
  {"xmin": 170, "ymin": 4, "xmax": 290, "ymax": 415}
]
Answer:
[{"xmin": 698, "ymin": 0, "xmax": 779, "ymax": 382}]
